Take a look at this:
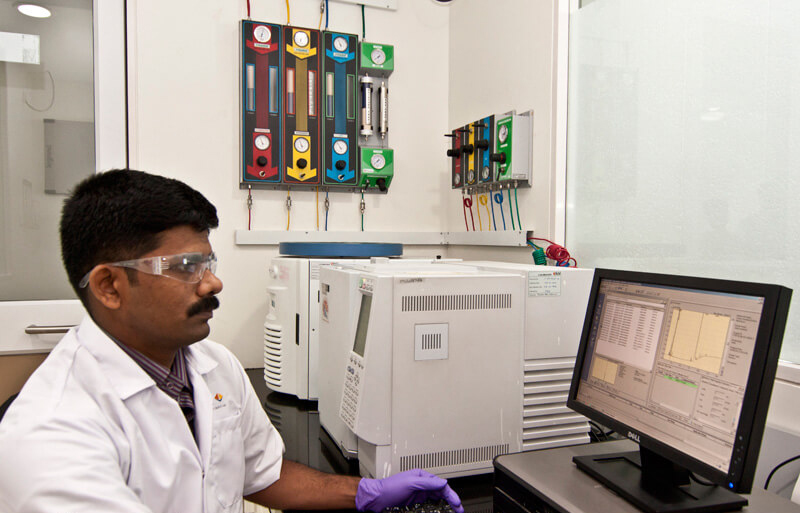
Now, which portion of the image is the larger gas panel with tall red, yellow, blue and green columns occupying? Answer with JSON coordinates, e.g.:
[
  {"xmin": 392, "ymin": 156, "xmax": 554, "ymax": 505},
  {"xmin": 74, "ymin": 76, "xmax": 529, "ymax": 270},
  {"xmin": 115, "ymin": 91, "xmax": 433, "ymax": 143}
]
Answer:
[{"xmin": 240, "ymin": 20, "xmax": 394, "ymax": 192}]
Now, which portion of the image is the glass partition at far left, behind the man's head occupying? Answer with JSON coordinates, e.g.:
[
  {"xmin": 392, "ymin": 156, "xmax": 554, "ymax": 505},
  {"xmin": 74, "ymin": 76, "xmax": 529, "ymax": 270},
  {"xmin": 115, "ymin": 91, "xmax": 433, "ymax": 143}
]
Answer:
[{"xmin": 0, "ymin": 0, "xmax": 96, "ymax": 301}]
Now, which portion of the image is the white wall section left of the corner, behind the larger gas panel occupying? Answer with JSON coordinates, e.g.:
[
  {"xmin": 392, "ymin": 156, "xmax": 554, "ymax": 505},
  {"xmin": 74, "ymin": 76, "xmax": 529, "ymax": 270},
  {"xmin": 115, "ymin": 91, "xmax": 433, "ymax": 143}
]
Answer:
[{"xmin": 128, "ymin": 0, "xmax": 450, "ymax": 367}]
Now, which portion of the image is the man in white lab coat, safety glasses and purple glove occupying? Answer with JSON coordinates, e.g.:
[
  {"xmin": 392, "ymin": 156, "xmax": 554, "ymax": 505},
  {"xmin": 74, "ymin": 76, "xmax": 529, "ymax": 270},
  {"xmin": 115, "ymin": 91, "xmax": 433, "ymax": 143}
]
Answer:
[{"xmin": 0, "ymin": 170, "xmax": 463, "ymax": 513}]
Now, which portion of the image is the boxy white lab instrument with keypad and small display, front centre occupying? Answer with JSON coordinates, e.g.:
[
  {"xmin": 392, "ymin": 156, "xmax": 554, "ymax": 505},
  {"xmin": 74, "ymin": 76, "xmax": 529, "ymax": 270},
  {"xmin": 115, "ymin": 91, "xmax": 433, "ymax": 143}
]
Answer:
[{"xmin": 319, "ymin": 263, "xmax": 524, "ymax": 477}]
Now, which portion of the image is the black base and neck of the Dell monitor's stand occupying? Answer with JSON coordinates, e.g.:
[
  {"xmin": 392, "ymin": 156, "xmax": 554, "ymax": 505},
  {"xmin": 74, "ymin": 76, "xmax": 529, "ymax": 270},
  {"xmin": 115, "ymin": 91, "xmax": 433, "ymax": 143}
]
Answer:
[{"xmin": 572, "ymin": 446, "xmax": 747, "ymax": 513}]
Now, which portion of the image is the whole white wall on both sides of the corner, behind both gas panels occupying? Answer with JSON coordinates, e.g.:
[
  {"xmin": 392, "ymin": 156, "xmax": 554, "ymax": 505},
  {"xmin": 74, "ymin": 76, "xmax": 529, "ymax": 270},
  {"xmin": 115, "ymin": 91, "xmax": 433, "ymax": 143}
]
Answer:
[{"xmin": 129, "ymin": 0, "xmax": 556, "ymax": 366}]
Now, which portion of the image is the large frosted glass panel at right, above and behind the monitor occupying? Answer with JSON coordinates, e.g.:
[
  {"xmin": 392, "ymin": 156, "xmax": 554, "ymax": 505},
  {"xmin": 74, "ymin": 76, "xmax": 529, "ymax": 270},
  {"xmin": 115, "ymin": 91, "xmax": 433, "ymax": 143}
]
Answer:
[{"xmin": 567, "ymin": 0, "xmax": 800, "ymax": 362}]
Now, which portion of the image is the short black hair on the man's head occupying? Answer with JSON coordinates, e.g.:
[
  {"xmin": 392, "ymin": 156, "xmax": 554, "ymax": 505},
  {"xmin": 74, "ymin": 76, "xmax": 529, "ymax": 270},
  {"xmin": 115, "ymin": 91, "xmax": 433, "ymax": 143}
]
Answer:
[{"xmin": 60, "ymin": 169, "xmax": 219, "ymax": 308}]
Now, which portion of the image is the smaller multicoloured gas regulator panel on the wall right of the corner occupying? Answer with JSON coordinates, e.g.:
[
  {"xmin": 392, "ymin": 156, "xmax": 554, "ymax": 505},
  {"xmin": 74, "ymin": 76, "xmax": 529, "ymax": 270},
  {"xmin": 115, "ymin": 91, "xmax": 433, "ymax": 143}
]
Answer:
[{"xmin": 445, "ymin": 111, "xmax": 533, "ymax": 191}]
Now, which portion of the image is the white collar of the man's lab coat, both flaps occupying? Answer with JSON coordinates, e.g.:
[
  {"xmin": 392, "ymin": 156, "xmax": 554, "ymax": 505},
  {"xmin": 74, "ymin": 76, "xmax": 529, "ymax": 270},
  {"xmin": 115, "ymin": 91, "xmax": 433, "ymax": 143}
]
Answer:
[{"xmin": 75, "ymin": 315, "xmax": 217, "ymax": 401}]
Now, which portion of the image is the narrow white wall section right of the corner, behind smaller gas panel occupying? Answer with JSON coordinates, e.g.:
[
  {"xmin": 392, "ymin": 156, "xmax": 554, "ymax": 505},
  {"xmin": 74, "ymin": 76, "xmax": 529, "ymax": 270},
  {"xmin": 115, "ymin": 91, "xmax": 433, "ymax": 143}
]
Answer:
[{"xmin": 442, "ymin": 0, "xmax": 563, "ymax": 262}]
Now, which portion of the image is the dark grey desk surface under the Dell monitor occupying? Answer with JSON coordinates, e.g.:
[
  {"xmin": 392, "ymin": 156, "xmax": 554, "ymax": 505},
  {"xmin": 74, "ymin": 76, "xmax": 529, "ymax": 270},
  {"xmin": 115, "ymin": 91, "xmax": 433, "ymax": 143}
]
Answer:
[{"xmin": 495, "ymin": 440, "xmax": 800, "ymax": 513}]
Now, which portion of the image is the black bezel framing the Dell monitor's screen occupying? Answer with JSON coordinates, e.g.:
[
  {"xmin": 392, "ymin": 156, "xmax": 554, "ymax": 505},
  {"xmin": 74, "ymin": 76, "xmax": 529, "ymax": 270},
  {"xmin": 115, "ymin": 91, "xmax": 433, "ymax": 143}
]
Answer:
[{"xmin": 567, "ymin": 269, "xmax": 792, "ymax": 493}]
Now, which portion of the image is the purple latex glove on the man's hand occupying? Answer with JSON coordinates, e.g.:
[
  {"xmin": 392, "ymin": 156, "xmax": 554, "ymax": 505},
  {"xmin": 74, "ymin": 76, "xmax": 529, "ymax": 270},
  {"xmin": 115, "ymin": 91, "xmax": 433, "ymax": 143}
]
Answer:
[{"xmin": 356, "ymin": 468, "xmax": 464, "ymax": 513}]
